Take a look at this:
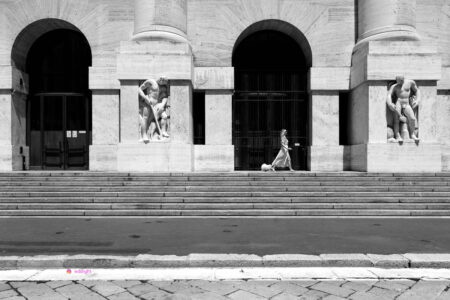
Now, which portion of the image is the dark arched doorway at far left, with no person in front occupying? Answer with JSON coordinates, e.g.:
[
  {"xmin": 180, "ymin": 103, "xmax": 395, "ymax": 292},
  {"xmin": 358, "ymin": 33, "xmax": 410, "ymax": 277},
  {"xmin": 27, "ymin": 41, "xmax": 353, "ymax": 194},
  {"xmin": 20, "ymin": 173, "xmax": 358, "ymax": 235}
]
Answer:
[{"xmin": 25, "ymin": 29, "xmax": 92, "ymax": 170}]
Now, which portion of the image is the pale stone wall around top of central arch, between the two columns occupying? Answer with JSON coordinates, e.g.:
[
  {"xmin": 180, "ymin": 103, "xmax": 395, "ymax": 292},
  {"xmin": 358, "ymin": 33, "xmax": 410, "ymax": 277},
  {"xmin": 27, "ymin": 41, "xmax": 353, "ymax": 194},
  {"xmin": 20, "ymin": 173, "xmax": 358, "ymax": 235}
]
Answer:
[{"xmin": 188, "ymin": 0, "xmax": 355, "ymax": 67}]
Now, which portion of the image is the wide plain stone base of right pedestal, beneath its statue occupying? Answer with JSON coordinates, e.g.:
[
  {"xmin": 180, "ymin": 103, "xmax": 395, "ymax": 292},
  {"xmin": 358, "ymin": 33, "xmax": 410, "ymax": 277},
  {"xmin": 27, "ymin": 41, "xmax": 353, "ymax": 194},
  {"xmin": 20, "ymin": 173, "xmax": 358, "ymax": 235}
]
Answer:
[{"xmin": 345, "ymin": 143, "xmax": 442, "ymax": 172}]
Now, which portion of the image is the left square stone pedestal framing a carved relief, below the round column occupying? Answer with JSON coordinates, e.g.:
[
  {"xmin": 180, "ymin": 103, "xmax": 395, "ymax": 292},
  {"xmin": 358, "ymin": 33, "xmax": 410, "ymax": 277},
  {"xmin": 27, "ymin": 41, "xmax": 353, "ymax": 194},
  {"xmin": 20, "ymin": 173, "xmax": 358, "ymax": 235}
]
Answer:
[{"xmin": 112, "ymin": 40, "xmax": 194, "ymax": 172}]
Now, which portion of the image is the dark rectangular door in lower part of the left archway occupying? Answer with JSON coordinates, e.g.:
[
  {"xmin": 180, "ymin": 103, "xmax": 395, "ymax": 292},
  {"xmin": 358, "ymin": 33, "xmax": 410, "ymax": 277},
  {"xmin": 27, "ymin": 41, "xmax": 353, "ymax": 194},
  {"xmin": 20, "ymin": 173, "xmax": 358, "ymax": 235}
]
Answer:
[{"xmin": 29, "ymin": 94, "xmax": 91, "ymax": 170}]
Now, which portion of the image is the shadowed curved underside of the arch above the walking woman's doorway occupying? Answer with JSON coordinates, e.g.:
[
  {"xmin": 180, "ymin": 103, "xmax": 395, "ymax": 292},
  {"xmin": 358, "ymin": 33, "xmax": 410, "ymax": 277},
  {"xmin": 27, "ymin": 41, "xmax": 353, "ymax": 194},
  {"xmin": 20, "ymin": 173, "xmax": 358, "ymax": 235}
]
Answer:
[{"xmin": 233, "ymin": 19, "xmax": 313, "ymax": 67}]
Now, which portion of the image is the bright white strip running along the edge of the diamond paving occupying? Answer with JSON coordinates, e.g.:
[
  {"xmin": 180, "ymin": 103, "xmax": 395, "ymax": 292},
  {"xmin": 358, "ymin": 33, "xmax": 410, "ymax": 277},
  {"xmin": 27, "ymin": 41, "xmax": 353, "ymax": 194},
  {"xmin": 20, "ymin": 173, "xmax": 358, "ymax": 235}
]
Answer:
[{"xmin": 0, "ymin": 267, "xmax": 450, "ymax": 282}]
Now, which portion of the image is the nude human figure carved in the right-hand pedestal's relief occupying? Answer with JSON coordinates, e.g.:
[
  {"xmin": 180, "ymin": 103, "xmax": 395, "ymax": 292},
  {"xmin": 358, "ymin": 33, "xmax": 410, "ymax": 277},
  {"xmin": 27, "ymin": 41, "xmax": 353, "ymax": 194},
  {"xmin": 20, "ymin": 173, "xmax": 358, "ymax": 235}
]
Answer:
[{"xmin": 386, "ymin": 76, "xmax": 420, "ymax": 142}]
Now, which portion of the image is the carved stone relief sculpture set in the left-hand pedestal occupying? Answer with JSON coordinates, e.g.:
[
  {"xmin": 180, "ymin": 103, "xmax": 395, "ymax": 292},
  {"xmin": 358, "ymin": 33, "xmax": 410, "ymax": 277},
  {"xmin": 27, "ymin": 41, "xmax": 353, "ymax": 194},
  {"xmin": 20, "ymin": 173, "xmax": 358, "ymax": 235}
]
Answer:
[{"xmin": 139, "ymin": 77, "xmax": 170, "ymax": 143}]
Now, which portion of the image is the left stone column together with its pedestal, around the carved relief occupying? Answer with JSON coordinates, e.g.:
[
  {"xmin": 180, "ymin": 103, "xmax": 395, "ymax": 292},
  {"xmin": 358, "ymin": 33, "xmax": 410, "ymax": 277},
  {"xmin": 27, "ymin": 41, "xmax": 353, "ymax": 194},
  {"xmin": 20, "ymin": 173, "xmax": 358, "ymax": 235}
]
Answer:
[{"xmin": 117, "ymin": 0, "xmax": 193, "ymax": 172}]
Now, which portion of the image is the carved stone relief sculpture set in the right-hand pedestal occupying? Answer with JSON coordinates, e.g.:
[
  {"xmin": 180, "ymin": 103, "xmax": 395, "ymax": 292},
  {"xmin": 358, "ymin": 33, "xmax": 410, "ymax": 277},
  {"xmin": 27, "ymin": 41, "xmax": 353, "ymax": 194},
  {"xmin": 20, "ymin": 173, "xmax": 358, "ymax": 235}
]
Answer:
[{"xmin": 386, "ymin": 76, "xmax": 420, "ymax": 143}]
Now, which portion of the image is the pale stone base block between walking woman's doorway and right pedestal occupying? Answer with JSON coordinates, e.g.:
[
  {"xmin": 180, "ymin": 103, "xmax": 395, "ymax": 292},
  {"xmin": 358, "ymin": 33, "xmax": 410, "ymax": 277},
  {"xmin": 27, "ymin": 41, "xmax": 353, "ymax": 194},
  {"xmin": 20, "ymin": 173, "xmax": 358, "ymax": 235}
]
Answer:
[{"xmin": 308, "ymin": 146, "xmax": 344, "ymax": 172}]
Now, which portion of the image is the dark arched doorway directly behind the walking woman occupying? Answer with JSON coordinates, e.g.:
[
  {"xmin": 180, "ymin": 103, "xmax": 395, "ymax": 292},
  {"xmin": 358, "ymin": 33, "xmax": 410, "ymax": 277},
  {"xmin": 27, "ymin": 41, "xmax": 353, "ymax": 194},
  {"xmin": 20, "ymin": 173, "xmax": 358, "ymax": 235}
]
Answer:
[{"xmin": 233, "ymin": 26, "xmax": 310, "ymax": 170}]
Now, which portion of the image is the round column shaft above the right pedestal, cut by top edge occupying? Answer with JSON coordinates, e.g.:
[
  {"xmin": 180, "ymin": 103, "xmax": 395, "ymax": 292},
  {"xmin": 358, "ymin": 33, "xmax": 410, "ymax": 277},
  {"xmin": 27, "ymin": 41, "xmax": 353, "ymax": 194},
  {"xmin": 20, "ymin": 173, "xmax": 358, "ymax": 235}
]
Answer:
[{"xmin": 358, "ymin": 0, "xmax": 419, "ymax": 43}]
